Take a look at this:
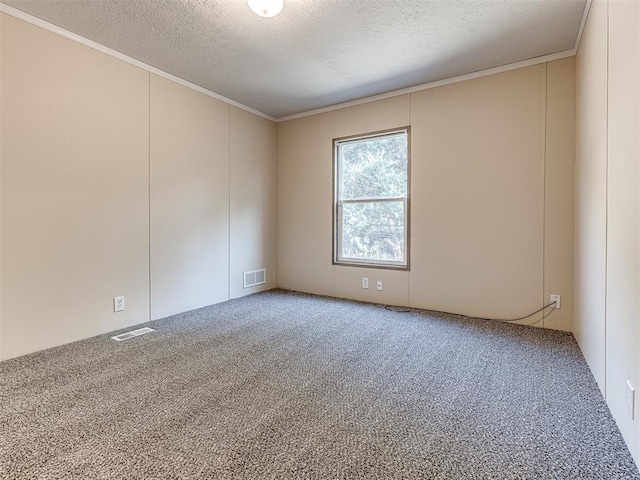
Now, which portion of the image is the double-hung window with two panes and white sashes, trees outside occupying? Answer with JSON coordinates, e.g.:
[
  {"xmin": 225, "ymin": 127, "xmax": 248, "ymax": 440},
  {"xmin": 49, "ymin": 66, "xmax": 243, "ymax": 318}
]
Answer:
[{"xmin": 334, "ymin": 128, "xmax": 409, "ymax": 269}]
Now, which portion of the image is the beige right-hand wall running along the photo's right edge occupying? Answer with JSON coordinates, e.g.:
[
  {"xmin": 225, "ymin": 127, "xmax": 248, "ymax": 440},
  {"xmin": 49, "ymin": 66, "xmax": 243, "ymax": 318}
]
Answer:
[{"xmin": 575, "ymin": 0, "xmax": 640, "ymax": 463}]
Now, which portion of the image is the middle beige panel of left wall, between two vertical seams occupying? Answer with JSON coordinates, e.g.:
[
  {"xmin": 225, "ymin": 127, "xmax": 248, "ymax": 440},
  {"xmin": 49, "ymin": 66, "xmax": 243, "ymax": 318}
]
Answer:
[{"xmin": 150, "ymin": 75, "xmax": 229, "ymax": 320}]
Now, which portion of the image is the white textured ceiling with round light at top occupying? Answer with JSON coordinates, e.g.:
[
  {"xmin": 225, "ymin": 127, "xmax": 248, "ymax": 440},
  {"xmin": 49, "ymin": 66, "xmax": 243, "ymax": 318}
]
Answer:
[{"xmin": 2, "ymin": 0, "xmax": 586, "ymax": 118}]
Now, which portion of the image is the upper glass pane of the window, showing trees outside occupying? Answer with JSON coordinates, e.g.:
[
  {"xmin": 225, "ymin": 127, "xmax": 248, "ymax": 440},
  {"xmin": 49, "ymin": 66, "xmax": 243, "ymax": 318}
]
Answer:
[{"xmin": 338, "ymin": 132, "xmax": 407, "ymax": 200}]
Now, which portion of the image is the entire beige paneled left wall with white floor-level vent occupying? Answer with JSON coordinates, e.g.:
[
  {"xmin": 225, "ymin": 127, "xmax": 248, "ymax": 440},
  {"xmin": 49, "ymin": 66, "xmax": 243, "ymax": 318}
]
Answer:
[{"xmin": 0, "ymin": 14, "xmax": 276, "ymax": 359}]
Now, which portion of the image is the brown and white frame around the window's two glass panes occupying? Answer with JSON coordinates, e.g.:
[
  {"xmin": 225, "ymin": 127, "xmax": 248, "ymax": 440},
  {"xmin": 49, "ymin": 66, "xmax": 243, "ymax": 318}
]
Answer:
[{"xmin": 331, "ymin": 126, "xmax": 411, "ymax": 271}]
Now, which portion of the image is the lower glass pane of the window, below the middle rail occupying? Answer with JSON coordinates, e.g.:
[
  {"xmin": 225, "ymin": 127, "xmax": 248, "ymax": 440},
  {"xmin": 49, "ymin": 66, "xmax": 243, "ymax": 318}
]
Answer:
[{"xmin": 342, "ymin": 201, "xmax": 405, "ymax": 262}]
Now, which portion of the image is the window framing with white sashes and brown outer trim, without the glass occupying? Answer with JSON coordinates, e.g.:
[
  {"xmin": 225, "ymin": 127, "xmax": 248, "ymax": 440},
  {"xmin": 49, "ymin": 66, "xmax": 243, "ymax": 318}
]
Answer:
[{"xmin": 333, "ymin": 127, "xmax": 411, "ymax": 270}]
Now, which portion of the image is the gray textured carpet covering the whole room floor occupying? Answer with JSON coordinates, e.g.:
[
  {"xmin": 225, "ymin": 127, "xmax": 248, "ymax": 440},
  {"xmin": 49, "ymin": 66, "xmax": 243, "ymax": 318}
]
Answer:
[{"xmin": 0, "ymin": 291, "xmax": 640, "ymax": 480}]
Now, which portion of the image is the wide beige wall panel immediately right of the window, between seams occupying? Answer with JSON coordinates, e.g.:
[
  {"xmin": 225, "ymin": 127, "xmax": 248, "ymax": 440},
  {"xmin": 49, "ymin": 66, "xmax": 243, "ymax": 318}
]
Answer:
[{"xmin": 410, "ymin": 64, "xmax": 546, "ymax": 318}]
